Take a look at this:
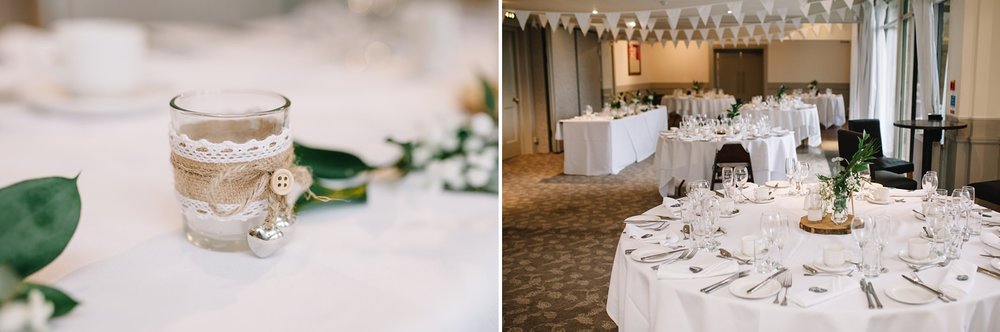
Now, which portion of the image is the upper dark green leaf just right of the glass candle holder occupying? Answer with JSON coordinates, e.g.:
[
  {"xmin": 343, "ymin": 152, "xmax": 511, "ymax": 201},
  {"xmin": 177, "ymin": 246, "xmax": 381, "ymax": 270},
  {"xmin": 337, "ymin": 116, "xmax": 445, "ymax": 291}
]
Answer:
[{"xmin": 295, "ymin": 143, "xmax": 373, "ymax": 179}]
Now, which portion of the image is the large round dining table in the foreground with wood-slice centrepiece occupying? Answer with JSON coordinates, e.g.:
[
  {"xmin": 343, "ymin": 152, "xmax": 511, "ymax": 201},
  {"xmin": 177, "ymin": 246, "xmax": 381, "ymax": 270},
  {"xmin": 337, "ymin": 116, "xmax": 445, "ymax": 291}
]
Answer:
[{"xmin": 607, "ymin": 189, "xmax": 1000, "ymax": 332}]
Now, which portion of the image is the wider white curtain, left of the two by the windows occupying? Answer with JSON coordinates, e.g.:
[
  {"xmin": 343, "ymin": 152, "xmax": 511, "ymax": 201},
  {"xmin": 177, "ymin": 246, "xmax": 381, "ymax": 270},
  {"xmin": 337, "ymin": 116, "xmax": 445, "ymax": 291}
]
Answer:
[{"xmin": 850, "ymin": 1, "xmax": 898, "ymax": 155}]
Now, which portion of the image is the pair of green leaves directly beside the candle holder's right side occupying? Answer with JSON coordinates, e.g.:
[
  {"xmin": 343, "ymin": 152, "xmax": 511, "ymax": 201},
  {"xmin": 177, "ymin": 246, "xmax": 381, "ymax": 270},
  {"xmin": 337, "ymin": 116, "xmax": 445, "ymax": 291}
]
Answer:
[{"xmin": 295, "ymin": 143, "xmax": 375, "ymax": 212}]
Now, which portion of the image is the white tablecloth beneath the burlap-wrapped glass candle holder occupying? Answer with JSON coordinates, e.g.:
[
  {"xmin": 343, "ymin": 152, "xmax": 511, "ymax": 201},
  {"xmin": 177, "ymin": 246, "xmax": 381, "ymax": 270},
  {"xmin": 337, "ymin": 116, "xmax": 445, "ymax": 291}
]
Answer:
[{"xmin": 0, "ymin": 10, "xmax": 500, "ymax": 331}]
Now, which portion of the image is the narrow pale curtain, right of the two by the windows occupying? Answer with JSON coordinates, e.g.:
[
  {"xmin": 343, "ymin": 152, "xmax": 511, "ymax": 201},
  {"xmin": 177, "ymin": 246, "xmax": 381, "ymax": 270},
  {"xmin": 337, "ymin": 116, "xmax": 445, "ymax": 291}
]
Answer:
[{"xmin": 912, "ymin": 0, "xmax": 942, "ymax": 118}]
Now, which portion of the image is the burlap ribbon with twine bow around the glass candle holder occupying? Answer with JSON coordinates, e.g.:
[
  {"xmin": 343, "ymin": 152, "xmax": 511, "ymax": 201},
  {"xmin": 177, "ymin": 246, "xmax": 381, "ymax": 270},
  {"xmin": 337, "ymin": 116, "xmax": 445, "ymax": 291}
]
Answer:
[{"xmin": 170, "ymin": 147, "xmax": 329, "ymax": 220}]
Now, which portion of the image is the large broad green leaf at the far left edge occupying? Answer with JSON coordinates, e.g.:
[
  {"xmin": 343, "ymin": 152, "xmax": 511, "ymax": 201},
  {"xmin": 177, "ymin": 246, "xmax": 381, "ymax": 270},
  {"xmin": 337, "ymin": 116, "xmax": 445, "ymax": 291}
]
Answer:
[{"xmin": 0, "ymin": 177, "xmax": 80, "ymax": 277}]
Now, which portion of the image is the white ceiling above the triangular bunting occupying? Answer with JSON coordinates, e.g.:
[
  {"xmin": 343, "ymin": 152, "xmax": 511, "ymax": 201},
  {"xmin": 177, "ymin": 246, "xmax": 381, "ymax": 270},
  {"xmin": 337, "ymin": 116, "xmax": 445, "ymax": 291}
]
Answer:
[{"xmin": 503, "ymin": 0, "xmax": 860, "ymax": 29}]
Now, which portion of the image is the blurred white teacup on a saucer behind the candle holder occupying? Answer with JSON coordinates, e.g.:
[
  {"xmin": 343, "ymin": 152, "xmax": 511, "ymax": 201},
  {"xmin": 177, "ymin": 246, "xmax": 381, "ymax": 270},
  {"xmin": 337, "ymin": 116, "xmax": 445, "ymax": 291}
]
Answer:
[{"xmin": 54, "ymin": 19, "xmax": 146, "ymax": 96}]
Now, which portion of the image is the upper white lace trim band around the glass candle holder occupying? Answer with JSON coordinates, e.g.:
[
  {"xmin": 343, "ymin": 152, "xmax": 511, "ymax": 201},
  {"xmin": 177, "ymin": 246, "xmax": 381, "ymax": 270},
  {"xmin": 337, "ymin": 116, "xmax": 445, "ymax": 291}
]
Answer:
[{"xmin": 170, "ymin": 128, "xmax": 292, "ymax": 164}]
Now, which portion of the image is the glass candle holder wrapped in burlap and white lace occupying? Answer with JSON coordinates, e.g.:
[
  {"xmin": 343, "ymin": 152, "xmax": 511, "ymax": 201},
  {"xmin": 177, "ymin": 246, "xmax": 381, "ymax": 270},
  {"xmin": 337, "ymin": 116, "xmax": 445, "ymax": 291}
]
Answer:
[{"xmin": 170, "ymin": 90, "xmax": 292, "ymax": 251}]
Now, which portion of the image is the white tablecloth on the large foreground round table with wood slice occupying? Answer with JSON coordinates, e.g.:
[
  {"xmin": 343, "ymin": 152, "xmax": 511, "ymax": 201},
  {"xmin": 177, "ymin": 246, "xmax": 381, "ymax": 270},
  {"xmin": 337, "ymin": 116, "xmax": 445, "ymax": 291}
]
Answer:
[{"xmin": 607, "ymin": 192, "xmax": 1000, "ymax": 332}]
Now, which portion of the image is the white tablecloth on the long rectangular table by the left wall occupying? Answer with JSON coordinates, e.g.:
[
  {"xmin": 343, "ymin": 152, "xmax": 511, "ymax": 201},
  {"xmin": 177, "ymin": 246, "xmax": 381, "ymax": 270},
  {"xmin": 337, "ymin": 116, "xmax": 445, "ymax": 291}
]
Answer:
[{"xmin": 556, "ymin": 108, "xmax": 667, "ymax": 175}]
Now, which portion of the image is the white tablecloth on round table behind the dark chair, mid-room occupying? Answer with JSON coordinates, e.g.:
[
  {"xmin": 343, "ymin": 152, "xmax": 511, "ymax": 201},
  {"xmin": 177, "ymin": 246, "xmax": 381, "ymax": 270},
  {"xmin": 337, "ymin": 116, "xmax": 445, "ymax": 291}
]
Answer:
[{"xmin": 655, "ymin": 134, "xmax": 798, "ymax": 197}]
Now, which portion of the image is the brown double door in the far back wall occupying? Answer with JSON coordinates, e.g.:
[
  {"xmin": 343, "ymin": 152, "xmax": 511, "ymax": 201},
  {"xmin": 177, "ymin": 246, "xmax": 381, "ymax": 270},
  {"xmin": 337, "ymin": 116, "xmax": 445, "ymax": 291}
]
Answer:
[{"xmin": 715, "ymin": 49, "xmax": 764, "ymax": 101}]
